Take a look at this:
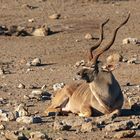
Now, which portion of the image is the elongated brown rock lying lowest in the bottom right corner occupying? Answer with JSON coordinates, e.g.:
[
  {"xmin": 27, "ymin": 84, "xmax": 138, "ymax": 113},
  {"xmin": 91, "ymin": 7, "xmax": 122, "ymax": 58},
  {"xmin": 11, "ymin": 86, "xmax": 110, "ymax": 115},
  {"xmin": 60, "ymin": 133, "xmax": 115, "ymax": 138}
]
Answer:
[{"xmin": 114, "ymin": 130, "xmax": 136, "ymax": 139}]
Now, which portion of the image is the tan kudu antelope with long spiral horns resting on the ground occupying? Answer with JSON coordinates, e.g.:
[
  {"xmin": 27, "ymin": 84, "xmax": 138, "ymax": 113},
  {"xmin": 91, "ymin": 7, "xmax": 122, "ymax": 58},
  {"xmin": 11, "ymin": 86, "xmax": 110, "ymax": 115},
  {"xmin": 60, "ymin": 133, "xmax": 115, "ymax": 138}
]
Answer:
[{"xmin": 45, "ymin": 14, "xmax": 130, "ymax": 117}]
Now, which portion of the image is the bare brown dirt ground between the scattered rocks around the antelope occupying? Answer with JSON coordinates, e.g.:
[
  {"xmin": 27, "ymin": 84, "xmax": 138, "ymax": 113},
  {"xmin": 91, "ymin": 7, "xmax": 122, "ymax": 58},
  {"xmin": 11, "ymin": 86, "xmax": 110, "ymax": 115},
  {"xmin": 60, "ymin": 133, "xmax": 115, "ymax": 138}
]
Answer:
[{"xmin": 0, "ymin": 0, "xmax": 140, "ymax": 140}]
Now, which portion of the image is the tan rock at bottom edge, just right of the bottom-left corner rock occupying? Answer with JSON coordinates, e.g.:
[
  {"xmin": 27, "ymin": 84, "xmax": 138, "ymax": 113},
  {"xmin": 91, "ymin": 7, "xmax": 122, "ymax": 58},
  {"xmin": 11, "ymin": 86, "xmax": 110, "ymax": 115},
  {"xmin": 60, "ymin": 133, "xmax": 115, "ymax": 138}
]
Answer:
[{"xmin": 29, "ymin": 131, "xmax": 48, "ymax": 140}]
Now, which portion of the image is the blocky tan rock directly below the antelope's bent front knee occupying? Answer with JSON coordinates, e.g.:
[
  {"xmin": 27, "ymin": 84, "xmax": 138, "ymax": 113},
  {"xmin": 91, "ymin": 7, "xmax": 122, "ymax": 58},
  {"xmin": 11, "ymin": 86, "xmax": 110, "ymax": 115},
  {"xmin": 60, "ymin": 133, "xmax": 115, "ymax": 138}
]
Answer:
[{"xmin": 81, "ymin": 122, "xmax": 93, "ymax": 133}]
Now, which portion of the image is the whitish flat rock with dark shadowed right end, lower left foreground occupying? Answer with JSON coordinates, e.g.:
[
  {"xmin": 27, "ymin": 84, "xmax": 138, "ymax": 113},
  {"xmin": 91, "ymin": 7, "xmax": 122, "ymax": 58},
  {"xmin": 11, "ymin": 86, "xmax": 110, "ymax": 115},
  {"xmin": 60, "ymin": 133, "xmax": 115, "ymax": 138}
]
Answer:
[{"xmin": 16, "ymin": 116, "xmax": 42, "ymax": 124}]
